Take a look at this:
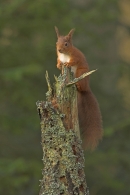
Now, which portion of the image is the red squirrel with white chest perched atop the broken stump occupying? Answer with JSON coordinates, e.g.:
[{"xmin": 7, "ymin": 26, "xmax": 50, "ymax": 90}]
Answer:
[{"xmin": 55, "ymin": 27, "xmax": 102, "ymax": 150}]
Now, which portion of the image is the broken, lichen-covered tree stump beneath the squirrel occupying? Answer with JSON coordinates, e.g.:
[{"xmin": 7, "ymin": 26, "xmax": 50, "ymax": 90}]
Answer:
[{"xmin": 36, "ymin": 68, "xmax": 89, "ymax": 195}]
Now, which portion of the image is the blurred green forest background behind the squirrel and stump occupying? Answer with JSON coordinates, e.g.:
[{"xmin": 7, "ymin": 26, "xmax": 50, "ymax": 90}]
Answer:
[{"xmin": 0, "ymin": 0, "xmax": 130, "ymax": 195}]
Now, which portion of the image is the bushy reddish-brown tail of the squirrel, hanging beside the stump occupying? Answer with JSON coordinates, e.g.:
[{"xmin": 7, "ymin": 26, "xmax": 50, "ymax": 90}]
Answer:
[{"xmin": 78, "ymin": 90, "xmax": 103, "ymax": 150}]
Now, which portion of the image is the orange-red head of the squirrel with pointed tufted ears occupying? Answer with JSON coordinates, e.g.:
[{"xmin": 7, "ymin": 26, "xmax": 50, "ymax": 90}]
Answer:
[{"xmin": 55, "ymin": 26, "xmax": 74, "ymax": 54}]
